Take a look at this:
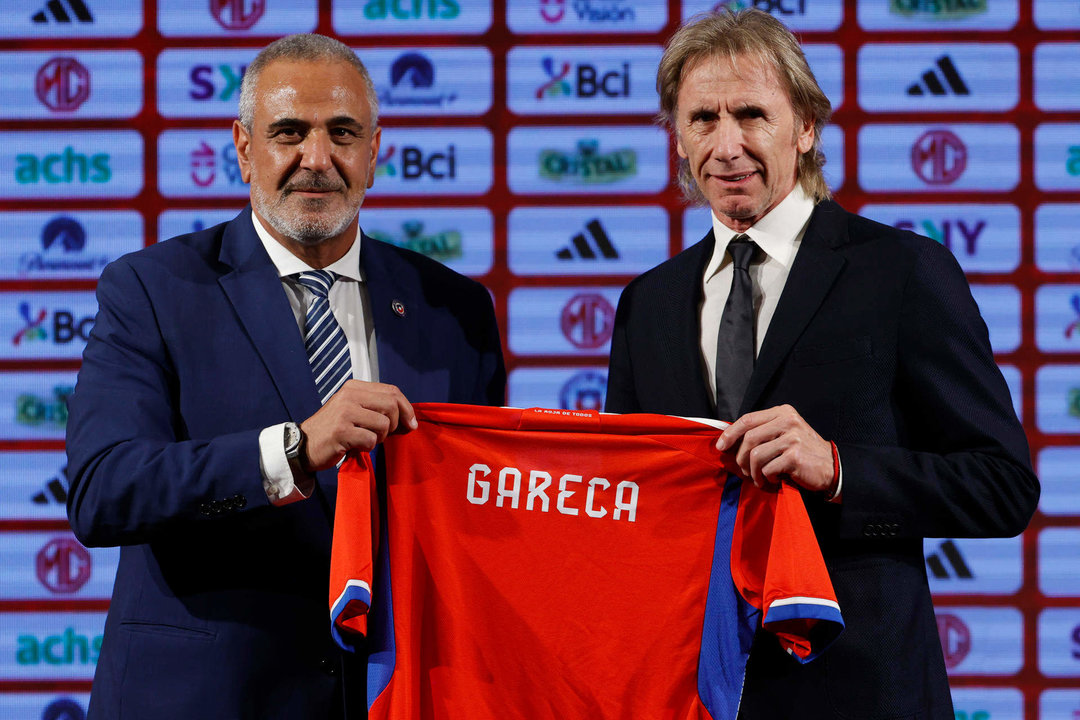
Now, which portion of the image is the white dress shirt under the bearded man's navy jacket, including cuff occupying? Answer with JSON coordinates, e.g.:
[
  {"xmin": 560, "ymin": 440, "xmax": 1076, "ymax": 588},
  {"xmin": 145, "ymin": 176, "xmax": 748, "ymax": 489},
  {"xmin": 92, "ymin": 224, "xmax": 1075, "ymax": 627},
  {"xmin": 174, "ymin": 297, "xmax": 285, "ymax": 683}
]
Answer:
[{"xmin": 252, "ymin": 213, "xmax": 379, "ymax": 505}]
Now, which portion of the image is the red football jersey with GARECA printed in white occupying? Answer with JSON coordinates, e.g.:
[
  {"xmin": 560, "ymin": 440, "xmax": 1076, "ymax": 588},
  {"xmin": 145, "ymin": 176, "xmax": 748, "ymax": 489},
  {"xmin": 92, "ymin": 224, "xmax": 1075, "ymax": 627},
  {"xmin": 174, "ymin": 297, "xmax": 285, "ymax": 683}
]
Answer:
[{"xmin": 330, "ymin": 404, "xmax": 842, "ymax": 720}]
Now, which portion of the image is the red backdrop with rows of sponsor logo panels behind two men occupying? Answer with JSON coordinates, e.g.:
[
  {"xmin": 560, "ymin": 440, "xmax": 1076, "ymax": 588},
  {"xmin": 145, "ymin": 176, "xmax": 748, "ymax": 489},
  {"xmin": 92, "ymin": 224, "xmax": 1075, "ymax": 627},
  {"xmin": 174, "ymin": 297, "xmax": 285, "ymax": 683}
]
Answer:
[{"xmin": 0, "ymin": 0, "xmax": 1080, "ymax": 720}]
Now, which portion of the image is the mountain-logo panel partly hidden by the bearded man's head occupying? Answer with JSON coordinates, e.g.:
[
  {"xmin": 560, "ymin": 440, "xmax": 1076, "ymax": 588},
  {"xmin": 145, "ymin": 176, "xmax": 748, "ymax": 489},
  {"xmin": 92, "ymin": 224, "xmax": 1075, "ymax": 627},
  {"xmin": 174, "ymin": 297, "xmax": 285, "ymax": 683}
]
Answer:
[{"xmin": 367, "ymin": 47, "xmax": 492, "ymax": 118}]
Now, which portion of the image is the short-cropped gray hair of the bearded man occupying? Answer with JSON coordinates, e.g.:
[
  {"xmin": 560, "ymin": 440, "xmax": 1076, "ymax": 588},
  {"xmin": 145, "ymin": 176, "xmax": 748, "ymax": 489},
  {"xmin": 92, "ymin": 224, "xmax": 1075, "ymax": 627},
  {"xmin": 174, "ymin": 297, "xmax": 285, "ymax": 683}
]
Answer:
[{"xmin": 237, "ymin": 32, "xmax": 379, "ymax": 133}]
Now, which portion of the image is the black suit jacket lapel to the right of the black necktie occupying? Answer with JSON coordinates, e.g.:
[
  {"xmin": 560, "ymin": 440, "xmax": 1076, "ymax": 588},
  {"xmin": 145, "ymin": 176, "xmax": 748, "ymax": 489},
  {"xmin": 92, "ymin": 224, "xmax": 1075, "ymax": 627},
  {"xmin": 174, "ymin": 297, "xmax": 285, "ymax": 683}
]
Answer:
[{"xmin": 740, "ymin": 201, "xmax": 847, "ymax": 415}]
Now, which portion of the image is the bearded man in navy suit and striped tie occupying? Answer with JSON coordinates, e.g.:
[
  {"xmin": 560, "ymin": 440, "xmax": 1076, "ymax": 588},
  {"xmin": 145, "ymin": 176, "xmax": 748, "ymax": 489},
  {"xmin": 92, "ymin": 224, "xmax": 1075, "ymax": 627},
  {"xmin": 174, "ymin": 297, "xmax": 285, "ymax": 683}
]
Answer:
[{"xmin": 67, "ymin": 35, "xmax": 505, "ymax": 720}]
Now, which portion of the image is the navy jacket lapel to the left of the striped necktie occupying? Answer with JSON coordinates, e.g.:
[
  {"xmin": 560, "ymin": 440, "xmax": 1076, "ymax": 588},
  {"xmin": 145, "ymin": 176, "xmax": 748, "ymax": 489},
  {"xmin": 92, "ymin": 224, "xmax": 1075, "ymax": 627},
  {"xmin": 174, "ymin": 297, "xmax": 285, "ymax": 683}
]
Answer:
[{"xmin": 218, "ymin": 209, "xmax": 320, "ymax": 422}]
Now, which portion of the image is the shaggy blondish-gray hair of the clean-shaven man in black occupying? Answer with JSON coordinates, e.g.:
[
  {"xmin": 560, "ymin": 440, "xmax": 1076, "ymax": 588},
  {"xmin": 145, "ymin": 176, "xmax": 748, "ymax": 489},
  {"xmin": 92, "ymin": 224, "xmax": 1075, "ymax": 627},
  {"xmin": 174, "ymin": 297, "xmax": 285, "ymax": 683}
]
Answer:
[{"xmin": 657, "ymin": 8, "xmax": 833, "ymax": 204}]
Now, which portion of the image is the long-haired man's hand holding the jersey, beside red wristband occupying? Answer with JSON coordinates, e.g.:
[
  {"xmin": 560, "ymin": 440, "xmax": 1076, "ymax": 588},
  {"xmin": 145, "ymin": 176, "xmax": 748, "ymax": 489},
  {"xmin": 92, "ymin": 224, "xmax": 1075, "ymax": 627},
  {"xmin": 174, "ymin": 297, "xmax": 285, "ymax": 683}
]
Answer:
[{"xmin": 716, "ymin": 405, "xmax": 836, "ymax": 493}]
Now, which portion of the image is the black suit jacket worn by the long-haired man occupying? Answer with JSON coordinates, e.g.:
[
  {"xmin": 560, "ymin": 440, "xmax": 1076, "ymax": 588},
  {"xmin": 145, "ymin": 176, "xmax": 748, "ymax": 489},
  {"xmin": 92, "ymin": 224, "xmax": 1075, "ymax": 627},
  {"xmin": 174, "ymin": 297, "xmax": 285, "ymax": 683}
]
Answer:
[{"xmin": 607, "ymin": 201, "xmax": 1039, "ymax": 720}]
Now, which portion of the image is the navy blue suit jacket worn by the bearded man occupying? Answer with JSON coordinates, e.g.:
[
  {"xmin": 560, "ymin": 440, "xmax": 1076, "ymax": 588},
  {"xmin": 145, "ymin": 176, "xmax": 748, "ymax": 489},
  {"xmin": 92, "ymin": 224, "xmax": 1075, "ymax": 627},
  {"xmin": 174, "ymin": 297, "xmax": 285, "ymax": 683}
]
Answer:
[{"xmin": 67, "ymin": 208, "xmax": 505, "ymax": 720}]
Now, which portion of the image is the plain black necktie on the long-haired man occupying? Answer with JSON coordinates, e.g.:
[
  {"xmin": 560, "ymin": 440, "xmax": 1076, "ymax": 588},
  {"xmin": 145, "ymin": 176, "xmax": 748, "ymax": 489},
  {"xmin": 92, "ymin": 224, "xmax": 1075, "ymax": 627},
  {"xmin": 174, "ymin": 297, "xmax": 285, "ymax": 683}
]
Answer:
[{"xmin": 716, "ymin": 235, "xmax": 757, "ymax": 421}]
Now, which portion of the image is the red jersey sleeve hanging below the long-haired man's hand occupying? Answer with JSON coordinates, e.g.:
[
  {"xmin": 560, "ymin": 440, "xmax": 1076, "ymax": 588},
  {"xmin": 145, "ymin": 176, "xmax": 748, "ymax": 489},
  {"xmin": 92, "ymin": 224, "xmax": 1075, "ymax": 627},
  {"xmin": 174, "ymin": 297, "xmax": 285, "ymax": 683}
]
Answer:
[{"xmin": 731, "ymin": 483, "xmax": 843, "ymax": 663}]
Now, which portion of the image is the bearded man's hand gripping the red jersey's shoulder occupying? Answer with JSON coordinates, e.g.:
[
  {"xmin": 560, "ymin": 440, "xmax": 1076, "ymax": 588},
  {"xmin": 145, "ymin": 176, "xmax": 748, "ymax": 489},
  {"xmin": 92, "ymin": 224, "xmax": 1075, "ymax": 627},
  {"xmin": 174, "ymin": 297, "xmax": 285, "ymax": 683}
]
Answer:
[{"xmin": 300, "ymin": 380, "xmax": 417, "ymax": 471}]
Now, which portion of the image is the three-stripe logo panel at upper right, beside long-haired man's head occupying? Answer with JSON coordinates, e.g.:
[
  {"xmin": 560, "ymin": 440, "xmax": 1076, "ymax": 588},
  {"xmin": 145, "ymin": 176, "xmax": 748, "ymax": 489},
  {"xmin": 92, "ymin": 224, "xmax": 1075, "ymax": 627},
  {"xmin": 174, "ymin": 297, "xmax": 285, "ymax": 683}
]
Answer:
[{"xmin": 859, "ymin": 43, "xmax": 1020, "ymax": 112}]
